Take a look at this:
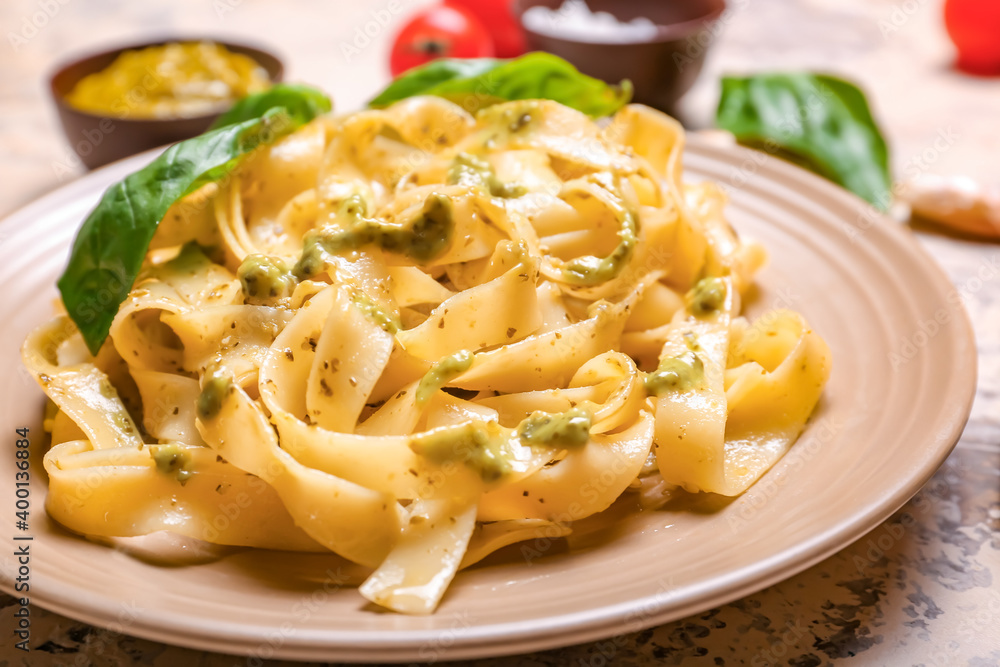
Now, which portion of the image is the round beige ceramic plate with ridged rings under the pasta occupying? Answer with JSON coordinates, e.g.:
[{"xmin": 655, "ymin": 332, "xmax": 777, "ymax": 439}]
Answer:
[{"xmin": 0, "ymin": 137, "xmax": 976, "ymax": 661}]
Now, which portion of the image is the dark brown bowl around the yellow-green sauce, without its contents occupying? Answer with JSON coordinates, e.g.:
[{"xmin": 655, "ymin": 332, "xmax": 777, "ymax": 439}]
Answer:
[{"xmin": 49, "ymin": 37, "xmax": 284, "ymax": 169}]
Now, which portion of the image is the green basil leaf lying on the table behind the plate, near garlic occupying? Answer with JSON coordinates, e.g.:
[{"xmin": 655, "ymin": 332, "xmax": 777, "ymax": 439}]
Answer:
[{"xmin": 715, "ymin": 73, "xmax": 892, "ymax": 210}]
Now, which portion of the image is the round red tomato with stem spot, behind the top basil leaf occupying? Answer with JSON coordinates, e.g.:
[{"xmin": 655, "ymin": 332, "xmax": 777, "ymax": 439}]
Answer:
[{"xmin": 389, "ymin": 7, "xmax": 495, "ymax": 76}]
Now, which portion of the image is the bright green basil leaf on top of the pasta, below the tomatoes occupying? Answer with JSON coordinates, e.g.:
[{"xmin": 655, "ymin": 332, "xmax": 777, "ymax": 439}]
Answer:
[{"xmin": 368, "ymin": 52, "xmax": 632, "ymax": 117}]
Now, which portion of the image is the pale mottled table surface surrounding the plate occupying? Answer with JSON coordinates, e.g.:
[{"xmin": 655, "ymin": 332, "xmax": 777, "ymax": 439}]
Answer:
[{"xmin": 0, "ymin": 0, "xmax": 1000, "ymax": 667}]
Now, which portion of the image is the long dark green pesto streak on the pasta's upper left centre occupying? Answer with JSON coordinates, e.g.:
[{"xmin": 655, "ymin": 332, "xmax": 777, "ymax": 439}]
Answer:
[{"xmin": 292, "ymin": 193, "xmax": 455, "ymax": 280}]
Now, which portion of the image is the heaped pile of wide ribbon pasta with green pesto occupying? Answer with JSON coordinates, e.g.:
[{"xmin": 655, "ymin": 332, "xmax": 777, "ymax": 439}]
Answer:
[{"xmin": 23, "ymin": 97, "xmax": 830, "ymax": 614}]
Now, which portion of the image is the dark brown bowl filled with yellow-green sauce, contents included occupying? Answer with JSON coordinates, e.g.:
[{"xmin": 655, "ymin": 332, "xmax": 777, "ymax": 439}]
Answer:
[{"xmin": 50, "ymin": 40, "xmax": 284, "ymax": 169}]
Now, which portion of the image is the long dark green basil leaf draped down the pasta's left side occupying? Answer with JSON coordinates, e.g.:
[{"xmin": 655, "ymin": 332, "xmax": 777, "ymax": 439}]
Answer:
[{"xmin": 58, "ymin": 86, "xmax": 330, "ymax": 355}]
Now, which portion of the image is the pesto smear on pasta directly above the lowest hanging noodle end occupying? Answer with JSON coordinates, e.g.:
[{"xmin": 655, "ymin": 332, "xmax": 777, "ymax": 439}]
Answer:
[{"xmin": 410, "ymin": 422, "xmax": 512, "ymax": 483}]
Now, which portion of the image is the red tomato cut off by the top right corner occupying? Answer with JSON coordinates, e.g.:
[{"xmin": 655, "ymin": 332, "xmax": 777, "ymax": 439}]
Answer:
[{"xmin": 944, "ymin": 0, "xmax": 1000, "ymax": 74}]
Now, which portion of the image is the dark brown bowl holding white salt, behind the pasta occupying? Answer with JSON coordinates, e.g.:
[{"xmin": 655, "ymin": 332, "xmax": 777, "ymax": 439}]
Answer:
[{"xmin": 514, "ymin": 0, "xmax": 726, "ymax": 111}]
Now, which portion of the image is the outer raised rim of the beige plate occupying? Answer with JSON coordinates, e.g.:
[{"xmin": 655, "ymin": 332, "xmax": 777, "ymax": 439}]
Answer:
[{"xmin": 0, "ymin": 133, "xmax": 978, "ymax": 662}]
